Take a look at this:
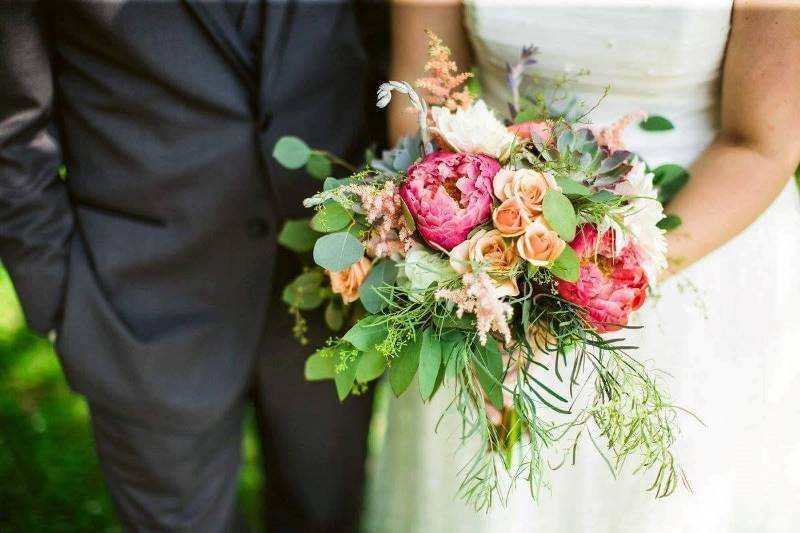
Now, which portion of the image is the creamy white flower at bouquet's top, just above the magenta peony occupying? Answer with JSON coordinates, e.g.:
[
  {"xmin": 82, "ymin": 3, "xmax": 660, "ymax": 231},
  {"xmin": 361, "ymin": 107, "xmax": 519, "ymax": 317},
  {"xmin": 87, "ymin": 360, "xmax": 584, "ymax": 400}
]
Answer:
[{"xmin": 431, "ymin": 100, "xmax": 514, "ymax": 159}]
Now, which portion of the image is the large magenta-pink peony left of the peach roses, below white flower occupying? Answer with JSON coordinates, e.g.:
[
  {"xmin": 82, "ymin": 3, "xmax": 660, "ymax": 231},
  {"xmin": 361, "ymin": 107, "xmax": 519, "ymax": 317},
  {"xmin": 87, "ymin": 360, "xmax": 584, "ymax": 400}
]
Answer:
[{"xmin": 400, "ymin": 152, "xmax": 500, "ymax": 251}]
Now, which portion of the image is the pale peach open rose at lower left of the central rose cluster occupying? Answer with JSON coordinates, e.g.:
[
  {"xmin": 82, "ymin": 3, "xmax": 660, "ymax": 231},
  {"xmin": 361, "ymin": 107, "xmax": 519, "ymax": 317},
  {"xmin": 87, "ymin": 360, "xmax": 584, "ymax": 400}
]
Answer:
[{"xmin": 450, "ymin": 229, "xmax": 519, "ymax": 296}]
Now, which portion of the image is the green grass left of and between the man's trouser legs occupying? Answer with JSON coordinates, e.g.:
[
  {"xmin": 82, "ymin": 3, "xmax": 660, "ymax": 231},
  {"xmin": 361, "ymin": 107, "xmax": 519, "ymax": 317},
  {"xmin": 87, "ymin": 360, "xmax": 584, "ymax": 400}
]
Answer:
[{"xmin": 0, "ymin": 268, "xmax": 262, "ymax": 533}]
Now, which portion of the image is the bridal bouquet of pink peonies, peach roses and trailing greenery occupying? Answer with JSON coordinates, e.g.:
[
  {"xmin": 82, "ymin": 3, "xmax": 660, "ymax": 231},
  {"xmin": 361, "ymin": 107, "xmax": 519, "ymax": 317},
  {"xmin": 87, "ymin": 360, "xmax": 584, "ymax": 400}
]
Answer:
[{"xmin": 274, "ymin": 34, "xmax": 688, "ymax": 509}]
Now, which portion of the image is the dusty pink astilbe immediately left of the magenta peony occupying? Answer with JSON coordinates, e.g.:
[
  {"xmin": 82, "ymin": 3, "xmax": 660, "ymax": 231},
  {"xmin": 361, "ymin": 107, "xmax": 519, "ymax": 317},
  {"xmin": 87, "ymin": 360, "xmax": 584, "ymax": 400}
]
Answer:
[{"xmin": 342, "ymin": 181, "xmax": 414, "ymax": 258}]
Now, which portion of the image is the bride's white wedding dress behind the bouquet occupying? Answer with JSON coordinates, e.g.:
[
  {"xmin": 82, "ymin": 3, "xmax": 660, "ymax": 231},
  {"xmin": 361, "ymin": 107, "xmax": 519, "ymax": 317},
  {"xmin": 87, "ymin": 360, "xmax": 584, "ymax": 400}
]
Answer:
[{"xmin": 364, "ymin": 0, "xmax": 800, "ymax": 533}]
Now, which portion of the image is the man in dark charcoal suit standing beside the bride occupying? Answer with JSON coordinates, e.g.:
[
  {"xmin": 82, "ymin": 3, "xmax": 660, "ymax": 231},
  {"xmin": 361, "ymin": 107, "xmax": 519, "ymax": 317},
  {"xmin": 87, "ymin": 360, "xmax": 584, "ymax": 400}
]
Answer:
[{"xmin": 0, "ymin": 0, "xmax": 386, "ymax": 532}]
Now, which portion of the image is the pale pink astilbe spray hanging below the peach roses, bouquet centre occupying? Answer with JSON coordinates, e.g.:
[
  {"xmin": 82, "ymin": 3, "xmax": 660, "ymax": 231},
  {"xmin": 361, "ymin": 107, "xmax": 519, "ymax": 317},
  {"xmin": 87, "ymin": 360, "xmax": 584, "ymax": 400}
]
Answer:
[{"xmin": 436, "ymin": 272, "xmax": 514, "ymax": 345}]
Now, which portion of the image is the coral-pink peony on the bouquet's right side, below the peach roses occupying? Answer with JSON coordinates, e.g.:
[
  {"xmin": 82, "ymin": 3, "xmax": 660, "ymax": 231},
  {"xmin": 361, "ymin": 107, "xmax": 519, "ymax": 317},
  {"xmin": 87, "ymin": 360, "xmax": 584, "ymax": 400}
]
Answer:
[{"xmin": 558, "ymin": 224, "xmax": 648, "ymax": 333}]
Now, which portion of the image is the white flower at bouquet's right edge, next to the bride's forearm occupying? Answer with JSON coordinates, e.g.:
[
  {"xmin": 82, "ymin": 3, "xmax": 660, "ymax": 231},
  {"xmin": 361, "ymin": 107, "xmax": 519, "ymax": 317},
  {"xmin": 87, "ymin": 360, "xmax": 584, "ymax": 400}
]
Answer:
[{"xmin": 614, "ymin": 161, "xmax": 667, "ymax": 285}]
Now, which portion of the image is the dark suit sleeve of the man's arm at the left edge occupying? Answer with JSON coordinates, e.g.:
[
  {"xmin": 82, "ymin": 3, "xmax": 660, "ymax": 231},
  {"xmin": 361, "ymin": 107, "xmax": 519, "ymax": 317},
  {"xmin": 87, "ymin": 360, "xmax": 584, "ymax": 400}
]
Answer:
[{"xmin": 0, "ymin": 1, "xmax": 74, "ymax": 332}]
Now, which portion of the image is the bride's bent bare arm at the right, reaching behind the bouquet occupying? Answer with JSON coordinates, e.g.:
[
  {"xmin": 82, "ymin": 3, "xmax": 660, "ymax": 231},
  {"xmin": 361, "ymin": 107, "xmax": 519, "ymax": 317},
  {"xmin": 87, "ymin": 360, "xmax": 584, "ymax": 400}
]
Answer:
[{"xmin": 668, "ymin": 0, "xmax": 800, "ymax": 272}]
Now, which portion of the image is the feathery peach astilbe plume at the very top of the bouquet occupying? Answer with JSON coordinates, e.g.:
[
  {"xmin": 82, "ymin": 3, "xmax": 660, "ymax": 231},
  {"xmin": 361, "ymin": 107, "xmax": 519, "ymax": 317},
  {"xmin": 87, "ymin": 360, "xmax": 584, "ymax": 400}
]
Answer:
[{"xmin": 415, "ymin": 30, "xmax": 472, "ymax": 111}]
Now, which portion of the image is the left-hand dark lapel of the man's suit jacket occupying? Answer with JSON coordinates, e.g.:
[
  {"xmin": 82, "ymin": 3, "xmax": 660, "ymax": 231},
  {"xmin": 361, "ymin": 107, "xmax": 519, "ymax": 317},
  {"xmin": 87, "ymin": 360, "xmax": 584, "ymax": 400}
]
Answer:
[{"xmin": 184, "ymin": 0, "xmax": 257, "ymax": 89}]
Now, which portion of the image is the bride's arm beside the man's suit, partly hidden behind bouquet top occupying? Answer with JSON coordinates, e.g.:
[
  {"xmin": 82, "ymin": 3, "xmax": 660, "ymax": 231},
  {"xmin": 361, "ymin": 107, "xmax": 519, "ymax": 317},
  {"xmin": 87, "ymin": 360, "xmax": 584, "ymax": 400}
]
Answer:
[{"xmin": 389, "ymin": 0, "xmax": 470, "ymax": 142}]
